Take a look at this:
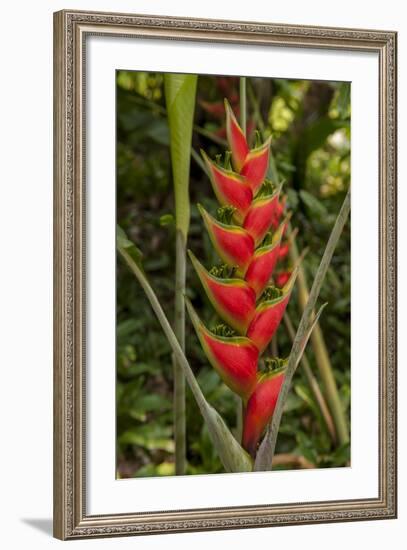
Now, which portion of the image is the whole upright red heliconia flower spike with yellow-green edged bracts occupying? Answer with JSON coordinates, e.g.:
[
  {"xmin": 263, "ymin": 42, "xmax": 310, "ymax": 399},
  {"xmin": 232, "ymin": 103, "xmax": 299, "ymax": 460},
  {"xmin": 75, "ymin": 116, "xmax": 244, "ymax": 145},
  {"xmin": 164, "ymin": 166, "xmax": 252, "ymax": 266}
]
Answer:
[{"xmin": 187, "ymin": 101, "xmax": 298, "ymax": 456}]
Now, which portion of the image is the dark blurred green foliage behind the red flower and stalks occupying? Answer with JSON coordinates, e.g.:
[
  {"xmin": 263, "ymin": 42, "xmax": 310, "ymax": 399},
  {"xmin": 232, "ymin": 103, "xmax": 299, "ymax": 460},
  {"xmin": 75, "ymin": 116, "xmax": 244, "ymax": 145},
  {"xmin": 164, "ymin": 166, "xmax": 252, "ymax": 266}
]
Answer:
[{"xmin": 116, "ymin": 71, "xmax": 350, "ymax": 478}]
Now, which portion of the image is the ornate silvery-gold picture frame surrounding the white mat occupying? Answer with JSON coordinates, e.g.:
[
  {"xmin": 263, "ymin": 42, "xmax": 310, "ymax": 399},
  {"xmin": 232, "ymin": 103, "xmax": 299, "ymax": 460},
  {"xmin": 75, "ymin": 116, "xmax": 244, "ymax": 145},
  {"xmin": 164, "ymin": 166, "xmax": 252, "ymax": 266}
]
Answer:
[{"xmin": 54, "ymin": 10, "xmax": 397, "ymax": 540}]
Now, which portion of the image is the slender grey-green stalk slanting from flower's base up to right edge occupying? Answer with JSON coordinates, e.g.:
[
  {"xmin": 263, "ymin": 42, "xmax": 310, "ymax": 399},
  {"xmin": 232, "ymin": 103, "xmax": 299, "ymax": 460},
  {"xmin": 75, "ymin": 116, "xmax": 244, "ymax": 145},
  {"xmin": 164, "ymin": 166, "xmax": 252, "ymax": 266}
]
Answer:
[{"xmin": 254, "ymin": 189, "xmax": 350, "ymax": 471}]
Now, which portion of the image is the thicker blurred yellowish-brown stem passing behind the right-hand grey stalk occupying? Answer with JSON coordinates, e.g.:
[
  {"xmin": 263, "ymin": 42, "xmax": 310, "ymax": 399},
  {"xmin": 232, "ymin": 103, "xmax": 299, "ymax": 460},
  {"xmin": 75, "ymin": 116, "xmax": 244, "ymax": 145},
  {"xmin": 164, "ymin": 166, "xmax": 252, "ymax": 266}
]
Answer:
[{"xmin": 289, "ymin": 227, "xmax": 349, "ymax": 445}]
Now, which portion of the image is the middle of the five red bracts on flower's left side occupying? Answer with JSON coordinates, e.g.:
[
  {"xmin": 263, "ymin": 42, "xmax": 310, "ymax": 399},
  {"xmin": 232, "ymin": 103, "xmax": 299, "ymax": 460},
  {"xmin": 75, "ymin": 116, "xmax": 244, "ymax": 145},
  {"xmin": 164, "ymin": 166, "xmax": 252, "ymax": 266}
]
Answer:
[{"xmin": 198, "ymin": 204, "xmax": 254, "ymax": 275}]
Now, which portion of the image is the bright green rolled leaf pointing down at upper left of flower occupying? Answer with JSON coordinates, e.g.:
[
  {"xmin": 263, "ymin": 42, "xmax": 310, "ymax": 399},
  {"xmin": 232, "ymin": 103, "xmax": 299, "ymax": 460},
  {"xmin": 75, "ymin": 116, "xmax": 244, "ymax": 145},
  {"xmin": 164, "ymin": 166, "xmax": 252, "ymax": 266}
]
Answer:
[{"xmin": 164, "ymin": 74, "xmax": 198, "ymax": 242}]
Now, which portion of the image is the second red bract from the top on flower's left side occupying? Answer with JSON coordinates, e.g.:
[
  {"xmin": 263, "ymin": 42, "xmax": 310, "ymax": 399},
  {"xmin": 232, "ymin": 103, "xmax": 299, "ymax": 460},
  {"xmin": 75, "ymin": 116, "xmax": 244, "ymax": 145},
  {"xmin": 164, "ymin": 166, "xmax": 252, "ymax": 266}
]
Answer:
[{"xmin": 202, "ymin": 151, "xmax": 253, "ymax": 222}]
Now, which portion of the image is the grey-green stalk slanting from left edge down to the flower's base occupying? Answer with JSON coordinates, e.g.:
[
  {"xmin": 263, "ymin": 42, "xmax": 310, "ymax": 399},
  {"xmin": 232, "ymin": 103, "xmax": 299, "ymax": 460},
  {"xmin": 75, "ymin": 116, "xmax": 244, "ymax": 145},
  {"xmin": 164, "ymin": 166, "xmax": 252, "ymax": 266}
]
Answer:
[{"xmin": 117, "ymin": 228, "xmax": 253, "ymax": 472}]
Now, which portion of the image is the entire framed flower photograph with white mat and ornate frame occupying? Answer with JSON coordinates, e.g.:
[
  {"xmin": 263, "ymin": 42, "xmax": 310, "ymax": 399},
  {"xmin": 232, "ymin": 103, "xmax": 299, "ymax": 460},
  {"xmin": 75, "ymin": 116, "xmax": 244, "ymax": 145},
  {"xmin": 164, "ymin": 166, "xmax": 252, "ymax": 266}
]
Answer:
[{"xmin": 54, "ymin": 10, "xmax": 397, "ymax": 539}]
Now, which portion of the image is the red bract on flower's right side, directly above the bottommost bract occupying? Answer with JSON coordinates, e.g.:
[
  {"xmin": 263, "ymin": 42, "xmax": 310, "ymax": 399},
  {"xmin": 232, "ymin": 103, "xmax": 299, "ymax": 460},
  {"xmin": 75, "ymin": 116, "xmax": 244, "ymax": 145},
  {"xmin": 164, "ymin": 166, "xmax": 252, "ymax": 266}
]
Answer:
[{"xmin": 246, "ymin": 268, "xmax": 298, "ymax": 353}]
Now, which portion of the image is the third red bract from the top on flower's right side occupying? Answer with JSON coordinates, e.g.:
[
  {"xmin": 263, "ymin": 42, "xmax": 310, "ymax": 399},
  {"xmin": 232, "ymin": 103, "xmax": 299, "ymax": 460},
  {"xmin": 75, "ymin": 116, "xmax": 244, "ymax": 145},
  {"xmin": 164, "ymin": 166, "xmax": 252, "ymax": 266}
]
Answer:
[{"xmin": 245, "ymin": 220, "xmax": 286, "ymax": 298}]
